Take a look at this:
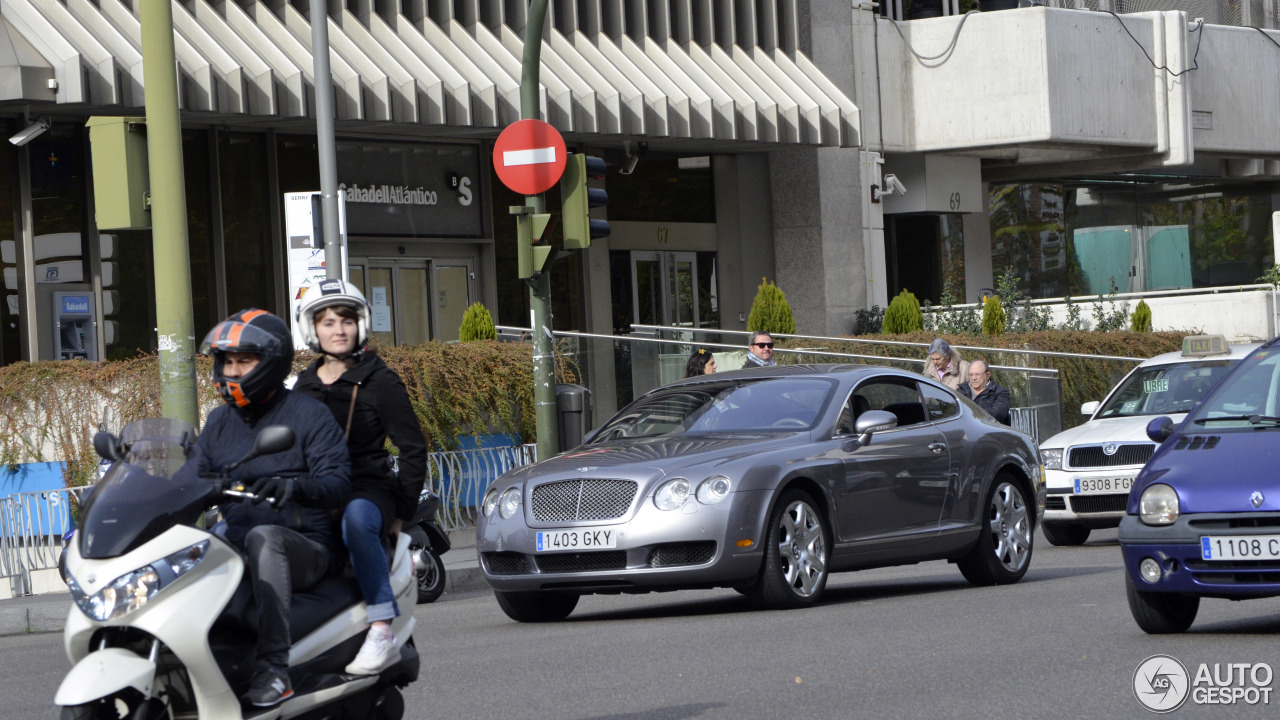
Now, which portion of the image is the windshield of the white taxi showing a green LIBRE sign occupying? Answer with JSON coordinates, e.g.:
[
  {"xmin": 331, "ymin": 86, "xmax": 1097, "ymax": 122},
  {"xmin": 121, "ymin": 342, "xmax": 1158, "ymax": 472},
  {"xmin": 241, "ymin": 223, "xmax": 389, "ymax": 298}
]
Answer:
[{"xmin": 1097, "ymin": 359, "xmax": 1233, "ymax": 418}]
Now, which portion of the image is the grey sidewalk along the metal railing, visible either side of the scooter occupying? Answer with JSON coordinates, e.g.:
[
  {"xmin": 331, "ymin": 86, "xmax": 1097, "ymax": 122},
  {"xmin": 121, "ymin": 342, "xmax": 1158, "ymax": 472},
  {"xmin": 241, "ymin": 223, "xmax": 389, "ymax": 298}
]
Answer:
[{"xmin": 0, "ymin": 529, "xmax": 489, "ymax": 635}]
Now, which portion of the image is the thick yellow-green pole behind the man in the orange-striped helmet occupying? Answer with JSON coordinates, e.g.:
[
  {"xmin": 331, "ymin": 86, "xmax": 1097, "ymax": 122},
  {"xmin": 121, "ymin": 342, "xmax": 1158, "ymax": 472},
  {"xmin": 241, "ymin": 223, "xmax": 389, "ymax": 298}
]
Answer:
[{"xmin": 138, "ymin": 0, "xmax": 200, "ymax": 425}]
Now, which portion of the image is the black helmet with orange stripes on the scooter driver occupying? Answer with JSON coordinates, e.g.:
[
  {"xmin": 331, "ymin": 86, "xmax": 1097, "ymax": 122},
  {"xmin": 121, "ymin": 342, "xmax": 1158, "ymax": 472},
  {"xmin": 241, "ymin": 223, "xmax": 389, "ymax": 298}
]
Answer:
[{"xmin": 200, "ymin": 309, "xmax": 293, "ymax": 407}]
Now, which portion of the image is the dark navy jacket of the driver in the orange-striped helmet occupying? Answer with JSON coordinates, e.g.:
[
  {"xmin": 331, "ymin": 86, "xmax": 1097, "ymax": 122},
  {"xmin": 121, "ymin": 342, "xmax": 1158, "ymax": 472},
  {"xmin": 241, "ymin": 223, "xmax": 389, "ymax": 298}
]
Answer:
[{"xmin": 196, "ymin": 387, "xmax": 351, "ymax": 557}]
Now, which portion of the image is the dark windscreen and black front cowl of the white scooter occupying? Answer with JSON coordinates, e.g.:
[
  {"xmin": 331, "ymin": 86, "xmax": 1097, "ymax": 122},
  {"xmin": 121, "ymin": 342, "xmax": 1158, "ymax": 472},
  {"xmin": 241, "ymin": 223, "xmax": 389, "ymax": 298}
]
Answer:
[{"xmin": 76, "ymin": 418, "xmax": 214, "ymax": 559}]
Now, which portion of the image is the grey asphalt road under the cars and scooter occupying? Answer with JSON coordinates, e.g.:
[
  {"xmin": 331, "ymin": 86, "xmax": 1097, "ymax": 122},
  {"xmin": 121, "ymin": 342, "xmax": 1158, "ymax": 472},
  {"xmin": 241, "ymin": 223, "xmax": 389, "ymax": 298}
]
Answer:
[{"xmin": 10, "ymin": 530, "xmax": 1280, "ymax": 720}]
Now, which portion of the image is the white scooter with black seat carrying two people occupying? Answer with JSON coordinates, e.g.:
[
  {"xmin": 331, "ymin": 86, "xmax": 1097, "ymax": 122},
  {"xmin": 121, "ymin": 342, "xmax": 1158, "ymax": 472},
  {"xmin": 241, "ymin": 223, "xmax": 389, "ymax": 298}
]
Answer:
[{"xmin": 55, "ymin": 419, "xmax": 419, "ymax": 720}]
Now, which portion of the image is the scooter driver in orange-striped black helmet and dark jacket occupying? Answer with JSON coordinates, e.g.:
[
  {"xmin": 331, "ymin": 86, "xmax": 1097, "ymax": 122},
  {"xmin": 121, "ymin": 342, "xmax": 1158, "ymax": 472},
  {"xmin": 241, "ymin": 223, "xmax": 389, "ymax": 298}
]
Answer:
[{"xmin": 195, "ymin": 309, "xmax": 351, "ymax": 707}]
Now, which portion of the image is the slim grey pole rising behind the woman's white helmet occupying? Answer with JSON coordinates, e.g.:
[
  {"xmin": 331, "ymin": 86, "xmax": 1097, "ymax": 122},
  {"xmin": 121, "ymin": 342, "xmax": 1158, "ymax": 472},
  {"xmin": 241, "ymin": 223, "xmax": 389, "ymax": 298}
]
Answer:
[{"xmin": 310, "ymin": 0, "xmax": 347, "ymax": 279}]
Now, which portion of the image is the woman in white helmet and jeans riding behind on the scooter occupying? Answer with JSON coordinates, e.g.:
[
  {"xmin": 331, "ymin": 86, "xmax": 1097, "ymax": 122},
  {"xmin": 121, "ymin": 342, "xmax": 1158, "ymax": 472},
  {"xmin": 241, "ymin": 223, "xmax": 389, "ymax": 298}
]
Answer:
[{"xmin": 293, "ymin": 278, "xmax": 426, "ymax": 675}]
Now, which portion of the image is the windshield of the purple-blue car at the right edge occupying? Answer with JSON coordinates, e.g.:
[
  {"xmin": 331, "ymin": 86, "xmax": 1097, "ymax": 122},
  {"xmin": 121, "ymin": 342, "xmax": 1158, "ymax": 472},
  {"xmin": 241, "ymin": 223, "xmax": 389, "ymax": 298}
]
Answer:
[{"xmin": 1190, "ymin": 347, "xmax": 1280, "ymax": 430}]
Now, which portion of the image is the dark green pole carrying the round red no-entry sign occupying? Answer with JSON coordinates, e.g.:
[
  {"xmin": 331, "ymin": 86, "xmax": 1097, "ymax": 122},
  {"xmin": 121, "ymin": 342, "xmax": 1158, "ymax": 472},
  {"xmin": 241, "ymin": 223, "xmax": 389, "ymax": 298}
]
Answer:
[{"xmin": 520, "ymin": 0, "xmax": 559, "ymax": 460}]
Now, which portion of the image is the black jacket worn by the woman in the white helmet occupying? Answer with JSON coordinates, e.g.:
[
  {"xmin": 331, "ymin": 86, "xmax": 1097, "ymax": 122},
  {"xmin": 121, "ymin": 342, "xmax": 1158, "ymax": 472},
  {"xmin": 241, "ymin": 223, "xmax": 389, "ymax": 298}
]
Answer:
[{"xmin": 293, "ymin": 352, "xmax": 426, "ymax": 530}]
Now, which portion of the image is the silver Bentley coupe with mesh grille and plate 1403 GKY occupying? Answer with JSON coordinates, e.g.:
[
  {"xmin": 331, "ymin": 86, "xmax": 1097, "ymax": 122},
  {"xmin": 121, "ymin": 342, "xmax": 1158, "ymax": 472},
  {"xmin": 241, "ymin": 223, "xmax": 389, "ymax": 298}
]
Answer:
[{"xmin": 476, "ymin": 365, "xmax": 1044, "ymax": 623}]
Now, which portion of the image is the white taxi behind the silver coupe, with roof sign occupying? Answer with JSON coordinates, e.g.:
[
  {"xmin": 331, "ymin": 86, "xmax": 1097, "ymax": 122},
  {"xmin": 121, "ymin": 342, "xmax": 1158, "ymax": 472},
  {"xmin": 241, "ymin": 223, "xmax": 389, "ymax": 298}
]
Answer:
[{"xmin": 1039, "ymin": 336, "xmax": 1260, "ymax": 546}]
